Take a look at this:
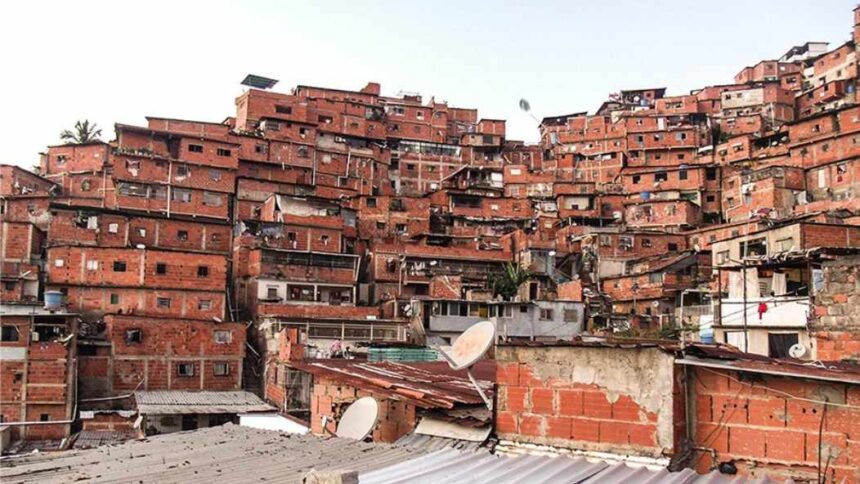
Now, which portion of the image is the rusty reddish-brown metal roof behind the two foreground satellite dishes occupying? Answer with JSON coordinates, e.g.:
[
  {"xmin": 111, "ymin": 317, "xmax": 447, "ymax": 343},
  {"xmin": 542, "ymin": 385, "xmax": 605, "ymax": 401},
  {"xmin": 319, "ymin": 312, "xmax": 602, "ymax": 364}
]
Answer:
[{"xmin": 291, "ymin": 359, "xmax": 495, "ymax": 409}]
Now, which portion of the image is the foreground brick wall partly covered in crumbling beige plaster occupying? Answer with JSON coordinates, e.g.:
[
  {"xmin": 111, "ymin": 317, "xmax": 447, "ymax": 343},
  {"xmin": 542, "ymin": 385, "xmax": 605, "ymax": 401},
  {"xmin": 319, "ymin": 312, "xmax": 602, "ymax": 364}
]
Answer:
[{"xmin": 495, "ymin": 345, "xmax": 683, "ymax": 457}]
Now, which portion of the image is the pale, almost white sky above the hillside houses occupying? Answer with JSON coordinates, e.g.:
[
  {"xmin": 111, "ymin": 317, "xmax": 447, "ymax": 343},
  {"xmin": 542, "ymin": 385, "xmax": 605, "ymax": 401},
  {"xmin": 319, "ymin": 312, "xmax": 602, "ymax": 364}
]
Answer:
[{"xmin": 0, "ymin": 0, "xmax": 855, "ymax": 167}]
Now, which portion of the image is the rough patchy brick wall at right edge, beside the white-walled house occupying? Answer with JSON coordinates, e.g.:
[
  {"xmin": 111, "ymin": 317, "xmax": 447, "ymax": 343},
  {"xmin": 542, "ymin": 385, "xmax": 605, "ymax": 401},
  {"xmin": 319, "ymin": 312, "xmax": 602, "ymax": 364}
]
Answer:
[{"xmin": 810, "ymin": 256, "xmax": 860, "ymax": 361}]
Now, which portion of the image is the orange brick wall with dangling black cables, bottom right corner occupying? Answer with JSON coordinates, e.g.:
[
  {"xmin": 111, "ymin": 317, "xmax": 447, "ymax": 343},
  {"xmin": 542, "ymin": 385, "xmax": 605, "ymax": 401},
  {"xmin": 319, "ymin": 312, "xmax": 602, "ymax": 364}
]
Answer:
[{"xmin": 690, "ymin": 368, "xmax": 860, "ymax": 483}]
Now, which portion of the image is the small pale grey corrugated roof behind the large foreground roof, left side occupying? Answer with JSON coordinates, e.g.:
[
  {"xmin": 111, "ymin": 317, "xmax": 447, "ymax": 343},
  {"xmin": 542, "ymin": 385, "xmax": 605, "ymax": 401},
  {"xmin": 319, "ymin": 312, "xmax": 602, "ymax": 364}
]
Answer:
[{"xmin": 134, "ymin": 390, "xmax": 275, "ymax": 415}]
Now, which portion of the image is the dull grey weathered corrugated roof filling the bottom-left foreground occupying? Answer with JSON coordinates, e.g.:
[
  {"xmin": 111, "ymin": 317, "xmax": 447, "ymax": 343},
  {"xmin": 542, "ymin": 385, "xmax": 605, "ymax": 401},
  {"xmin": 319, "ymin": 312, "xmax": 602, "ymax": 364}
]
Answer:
[{"xmin": 0, "ymin": 424, "xmax": 425, "ymax": 484}]
